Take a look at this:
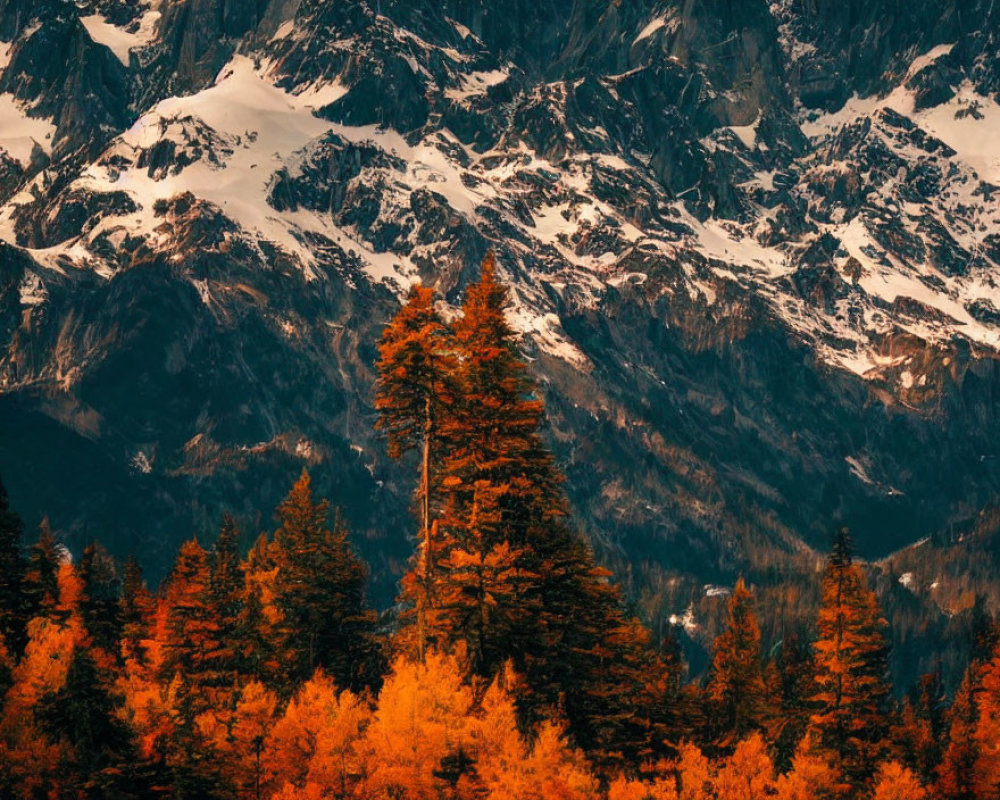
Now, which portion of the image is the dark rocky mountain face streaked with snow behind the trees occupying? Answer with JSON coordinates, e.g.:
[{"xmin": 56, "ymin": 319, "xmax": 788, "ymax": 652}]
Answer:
[{"xmin": 0, "ymin": 0, "xmax": 1000, "ymax": 640}]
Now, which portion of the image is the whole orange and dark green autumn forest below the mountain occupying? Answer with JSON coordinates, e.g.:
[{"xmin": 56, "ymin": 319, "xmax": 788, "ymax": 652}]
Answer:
[{"xmin": 0, "ymin": 256, "xmax": 1000, "ymax": 800}]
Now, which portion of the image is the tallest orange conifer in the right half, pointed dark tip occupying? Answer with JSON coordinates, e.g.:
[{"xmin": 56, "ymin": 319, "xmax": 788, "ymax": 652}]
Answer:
[{"xmin": 810, "ymin": 530, "xmax": 890, "ymax": 786}]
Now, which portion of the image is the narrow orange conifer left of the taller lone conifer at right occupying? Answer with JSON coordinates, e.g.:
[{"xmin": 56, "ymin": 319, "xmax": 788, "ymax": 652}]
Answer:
[{"xmin": 708, "ymin": 578, "xmax": 769, "ymax": 751}]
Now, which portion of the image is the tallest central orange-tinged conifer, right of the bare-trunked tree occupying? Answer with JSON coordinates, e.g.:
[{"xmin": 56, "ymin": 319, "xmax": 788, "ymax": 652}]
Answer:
[{"xmin": 386, "ymin": 254, "xmax": 650, "ymax": 763}]
